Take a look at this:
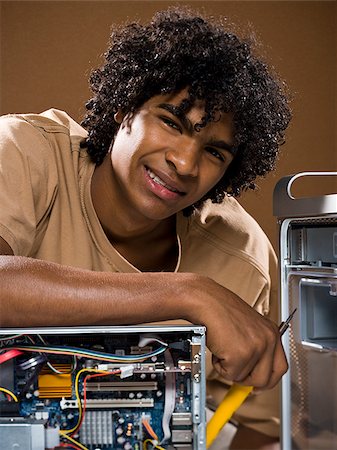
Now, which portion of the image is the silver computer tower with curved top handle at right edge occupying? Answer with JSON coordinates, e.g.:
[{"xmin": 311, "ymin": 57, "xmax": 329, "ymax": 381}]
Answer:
[{"xmin": 274, "ymin": 172, "xmax": 337, "ymax": 450}]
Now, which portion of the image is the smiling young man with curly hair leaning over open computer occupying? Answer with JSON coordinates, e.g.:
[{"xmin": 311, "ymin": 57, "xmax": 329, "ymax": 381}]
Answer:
[{"xmin": 0, "ymin": 9, "xmax": 290, "ymax": 445}]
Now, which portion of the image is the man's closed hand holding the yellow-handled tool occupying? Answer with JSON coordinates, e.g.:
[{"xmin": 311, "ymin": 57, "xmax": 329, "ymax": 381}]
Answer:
[{"xmin": 186, "ymin": 278, "xmax": 288, "ymax": 389}]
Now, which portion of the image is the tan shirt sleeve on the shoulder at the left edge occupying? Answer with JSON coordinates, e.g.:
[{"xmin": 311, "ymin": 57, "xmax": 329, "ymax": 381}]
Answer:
[{"xmin": 0, "ymin": 115, "xmax": 57, "ymax": 256}]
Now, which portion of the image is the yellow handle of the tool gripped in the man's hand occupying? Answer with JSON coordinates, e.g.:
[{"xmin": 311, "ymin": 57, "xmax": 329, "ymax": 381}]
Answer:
[{"xmin": 206, "ymin": 384, "xmax": 253, "ymax": 448}]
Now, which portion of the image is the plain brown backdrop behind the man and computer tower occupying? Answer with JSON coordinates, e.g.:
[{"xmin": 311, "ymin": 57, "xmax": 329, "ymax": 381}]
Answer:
[{"xmin": 0, "ymin": 1, "xmax": 337, "ymax": 247}]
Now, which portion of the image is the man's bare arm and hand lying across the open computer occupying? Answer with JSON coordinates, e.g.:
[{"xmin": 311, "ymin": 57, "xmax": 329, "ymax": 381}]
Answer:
[{"xmin": 0, "ymin": 239, "xmax": 287, "ymax": 388}]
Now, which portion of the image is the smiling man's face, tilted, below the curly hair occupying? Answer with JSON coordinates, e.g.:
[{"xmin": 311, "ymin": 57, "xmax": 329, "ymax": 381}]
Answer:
[{"xmin": 111, "ymin": 90, "xmax": 234, "ymax": 220}]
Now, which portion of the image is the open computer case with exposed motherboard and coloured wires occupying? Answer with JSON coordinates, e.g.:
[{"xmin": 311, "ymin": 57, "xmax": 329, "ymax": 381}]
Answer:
[{"xmin": 0, "ymin": 327, "xmax": 205, "ymax": 450}]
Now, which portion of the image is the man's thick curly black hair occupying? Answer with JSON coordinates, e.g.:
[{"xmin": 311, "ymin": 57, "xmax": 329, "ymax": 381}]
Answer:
[{"xmin": 82, "ymin": 7, "xmax": 291, "ymax": 206}]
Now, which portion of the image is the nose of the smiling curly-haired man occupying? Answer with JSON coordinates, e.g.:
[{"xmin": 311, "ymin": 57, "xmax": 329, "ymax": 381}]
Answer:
[{"xmin": 166, "ymin": 138, "xmax": 200, "ymax": 177}]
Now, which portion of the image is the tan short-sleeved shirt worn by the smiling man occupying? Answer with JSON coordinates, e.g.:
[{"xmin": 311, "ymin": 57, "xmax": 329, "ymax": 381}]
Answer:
[{"xmin": 0, "ymin": 110, "xmax": 279, "ymax": 436}]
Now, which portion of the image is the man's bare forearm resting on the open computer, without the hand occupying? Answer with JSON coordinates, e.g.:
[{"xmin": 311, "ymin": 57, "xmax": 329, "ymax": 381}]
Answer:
[{"xmin": 0, "ymin": 256, "xmax": 197, "ymax": 327}]
